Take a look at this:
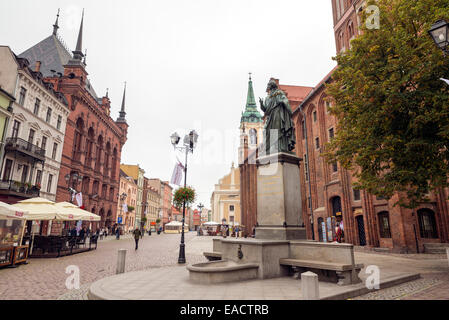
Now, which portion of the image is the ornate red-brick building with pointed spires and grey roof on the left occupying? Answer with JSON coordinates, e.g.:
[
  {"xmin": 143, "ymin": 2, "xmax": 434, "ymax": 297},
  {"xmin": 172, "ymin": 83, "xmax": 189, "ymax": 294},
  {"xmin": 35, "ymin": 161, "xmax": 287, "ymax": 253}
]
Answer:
[{"xmin": 19, "ymin": 15, "xmax": 128, "ymax": 231}]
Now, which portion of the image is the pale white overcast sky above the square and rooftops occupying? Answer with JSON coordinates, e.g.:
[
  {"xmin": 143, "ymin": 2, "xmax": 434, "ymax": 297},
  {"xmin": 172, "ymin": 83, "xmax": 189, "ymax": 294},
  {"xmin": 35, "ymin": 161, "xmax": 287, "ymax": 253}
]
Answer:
[{"xmin": 0, "ymin": 0, "xmax": 335, "ymax": 208}]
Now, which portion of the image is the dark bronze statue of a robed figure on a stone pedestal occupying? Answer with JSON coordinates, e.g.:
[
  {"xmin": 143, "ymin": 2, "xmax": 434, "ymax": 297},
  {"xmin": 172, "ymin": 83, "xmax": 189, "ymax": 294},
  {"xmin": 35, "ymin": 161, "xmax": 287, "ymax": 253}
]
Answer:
[{"xmin": 259, "ymin": 80, "xmax": 296, "ymax": 155}]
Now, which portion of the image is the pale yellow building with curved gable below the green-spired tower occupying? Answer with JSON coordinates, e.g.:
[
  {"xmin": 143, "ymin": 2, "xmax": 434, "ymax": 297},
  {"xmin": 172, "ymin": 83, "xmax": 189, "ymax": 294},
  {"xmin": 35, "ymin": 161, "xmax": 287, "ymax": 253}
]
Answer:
[{"xmin": 211, "ymin": 163, "xmax": 241, "ymax": 225}]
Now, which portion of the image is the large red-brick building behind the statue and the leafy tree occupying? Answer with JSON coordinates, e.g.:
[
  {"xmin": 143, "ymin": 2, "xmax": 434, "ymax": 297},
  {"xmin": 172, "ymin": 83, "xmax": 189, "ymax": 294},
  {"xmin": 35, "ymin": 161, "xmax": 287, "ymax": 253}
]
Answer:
[{"xmin": 240, "ymin": 0, "xmax": 449, "ymax": 253}]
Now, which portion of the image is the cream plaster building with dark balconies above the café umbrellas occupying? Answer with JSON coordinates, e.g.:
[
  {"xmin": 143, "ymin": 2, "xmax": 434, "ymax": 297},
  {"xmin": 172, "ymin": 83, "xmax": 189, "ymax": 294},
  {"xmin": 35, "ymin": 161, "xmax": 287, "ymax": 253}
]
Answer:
[{"xmin": 0, "ymin": 47, "xmax": 70, "ymax": 203}]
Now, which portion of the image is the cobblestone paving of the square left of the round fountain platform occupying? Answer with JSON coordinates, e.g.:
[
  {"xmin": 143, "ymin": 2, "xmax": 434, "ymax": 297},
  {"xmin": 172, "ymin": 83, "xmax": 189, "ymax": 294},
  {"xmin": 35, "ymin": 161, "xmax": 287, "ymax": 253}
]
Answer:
[{"xmin": 0, "ymin": 232, "xmax": 206, "ymax": 300}]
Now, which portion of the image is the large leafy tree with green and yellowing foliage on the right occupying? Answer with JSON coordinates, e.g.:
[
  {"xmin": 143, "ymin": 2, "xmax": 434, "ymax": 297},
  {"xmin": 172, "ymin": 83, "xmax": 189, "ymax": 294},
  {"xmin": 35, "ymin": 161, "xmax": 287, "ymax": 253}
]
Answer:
[{"xmin": 325, "ymin": 0, "xmax": 449, "ymax": 208}]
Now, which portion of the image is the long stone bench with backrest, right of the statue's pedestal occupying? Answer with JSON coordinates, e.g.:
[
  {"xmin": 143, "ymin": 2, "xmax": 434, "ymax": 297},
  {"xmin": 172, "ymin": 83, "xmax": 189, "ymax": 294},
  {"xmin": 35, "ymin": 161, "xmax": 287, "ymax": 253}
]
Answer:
[{"xmin": 279, "ymin": 241, "xmax": 364, "ymax": 285}]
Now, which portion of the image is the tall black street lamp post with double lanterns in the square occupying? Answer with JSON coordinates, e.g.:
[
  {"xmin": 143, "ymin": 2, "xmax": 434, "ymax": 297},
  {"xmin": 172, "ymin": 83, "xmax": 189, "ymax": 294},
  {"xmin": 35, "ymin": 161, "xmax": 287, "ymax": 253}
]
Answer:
[{"xmin": 170, "ymin": 130, "xmax": 198, "ymax": 264}]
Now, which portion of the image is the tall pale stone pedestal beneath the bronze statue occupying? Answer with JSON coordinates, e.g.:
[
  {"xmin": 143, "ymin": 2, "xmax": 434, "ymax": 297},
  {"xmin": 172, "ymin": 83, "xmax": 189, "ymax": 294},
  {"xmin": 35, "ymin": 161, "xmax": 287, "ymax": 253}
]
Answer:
[{"xmin": 256, "ymin": 153, "xmax": 307, "ymax": 240}]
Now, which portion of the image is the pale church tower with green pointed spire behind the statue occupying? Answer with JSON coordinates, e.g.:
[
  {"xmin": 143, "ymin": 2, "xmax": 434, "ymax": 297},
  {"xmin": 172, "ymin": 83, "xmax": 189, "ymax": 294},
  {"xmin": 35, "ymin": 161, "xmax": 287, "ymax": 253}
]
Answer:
[{"xmin": 239, "ymin": 73, "xmax": 263, "ymax": 164}]
